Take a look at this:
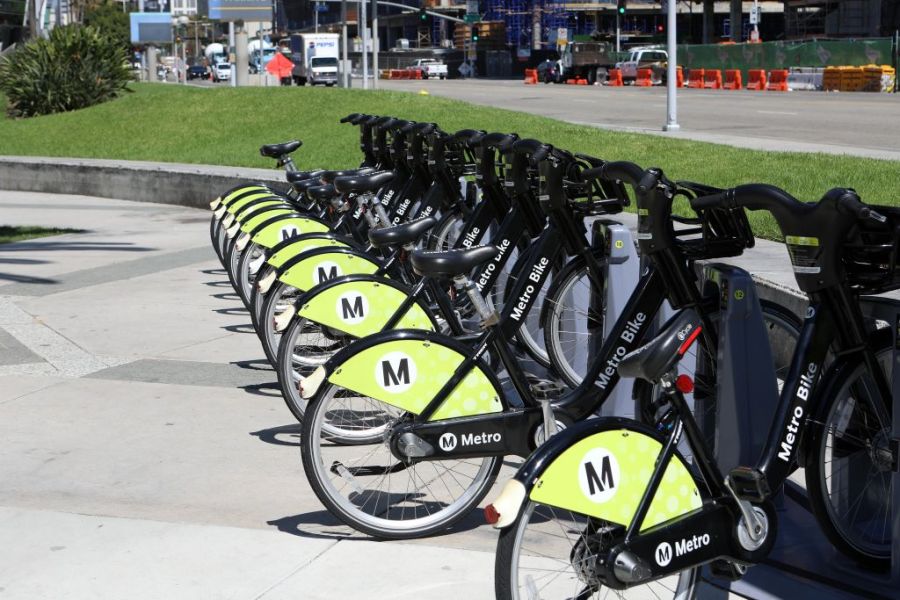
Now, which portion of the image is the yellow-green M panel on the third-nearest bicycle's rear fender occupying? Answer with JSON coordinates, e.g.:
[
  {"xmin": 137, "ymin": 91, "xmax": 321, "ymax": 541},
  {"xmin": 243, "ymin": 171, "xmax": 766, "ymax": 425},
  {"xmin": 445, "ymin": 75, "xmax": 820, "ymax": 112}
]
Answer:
[{"xmin": 298, "ymin": 281, "xmax": 434, "ymax": 338}]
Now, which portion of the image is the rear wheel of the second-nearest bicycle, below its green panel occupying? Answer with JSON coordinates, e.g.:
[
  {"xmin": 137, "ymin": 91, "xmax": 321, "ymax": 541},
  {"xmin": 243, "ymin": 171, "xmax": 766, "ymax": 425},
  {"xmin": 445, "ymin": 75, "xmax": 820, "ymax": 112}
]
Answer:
[{"xmin": 301, "ymin": 382, "xmax": 502, "ymax": 539}]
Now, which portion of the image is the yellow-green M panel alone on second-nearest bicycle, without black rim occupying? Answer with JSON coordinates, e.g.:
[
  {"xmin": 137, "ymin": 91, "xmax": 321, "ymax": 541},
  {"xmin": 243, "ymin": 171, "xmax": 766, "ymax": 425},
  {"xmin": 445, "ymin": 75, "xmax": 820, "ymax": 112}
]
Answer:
[{"xmin": 328, "ymin": 339, "xmax": 502, "ymax": 421}]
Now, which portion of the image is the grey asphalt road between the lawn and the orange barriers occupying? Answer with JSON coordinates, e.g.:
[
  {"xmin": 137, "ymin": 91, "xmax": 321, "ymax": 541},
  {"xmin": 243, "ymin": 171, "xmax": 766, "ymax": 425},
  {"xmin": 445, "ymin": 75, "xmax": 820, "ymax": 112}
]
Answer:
[{"xmin": 378, "ymin": 80, "xmax": 900, "ymax": 160}]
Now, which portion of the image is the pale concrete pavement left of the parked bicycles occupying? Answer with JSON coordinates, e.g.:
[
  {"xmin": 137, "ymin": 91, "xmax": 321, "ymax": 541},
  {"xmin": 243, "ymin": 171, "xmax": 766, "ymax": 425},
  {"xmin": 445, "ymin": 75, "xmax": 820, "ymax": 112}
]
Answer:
[{"xmin": 0, "ymin": 192, "xmax": 836, "ymax": 600}]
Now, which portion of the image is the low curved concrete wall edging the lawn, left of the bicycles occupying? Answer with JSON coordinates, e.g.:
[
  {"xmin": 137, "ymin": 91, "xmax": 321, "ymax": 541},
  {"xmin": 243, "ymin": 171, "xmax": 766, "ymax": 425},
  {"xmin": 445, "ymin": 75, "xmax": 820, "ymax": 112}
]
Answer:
[{"xmin": 0, "ymin": 156, "xmax": 284, "ymax": 208}]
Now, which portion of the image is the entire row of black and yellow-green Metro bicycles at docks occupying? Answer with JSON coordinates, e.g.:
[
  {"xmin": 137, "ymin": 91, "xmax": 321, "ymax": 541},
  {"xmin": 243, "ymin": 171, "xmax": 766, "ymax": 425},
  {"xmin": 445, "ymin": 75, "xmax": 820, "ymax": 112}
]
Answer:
[{"xmin": 210, "ymin": 114, "xmax": 900, "ymax": 599}]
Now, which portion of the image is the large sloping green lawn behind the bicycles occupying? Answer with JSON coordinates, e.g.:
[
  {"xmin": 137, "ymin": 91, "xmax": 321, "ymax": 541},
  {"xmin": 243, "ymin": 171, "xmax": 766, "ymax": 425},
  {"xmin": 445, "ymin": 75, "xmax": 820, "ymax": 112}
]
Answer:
[{"xmin": 0, "ymin": 84, "xmax": 900, "ymax": 237}]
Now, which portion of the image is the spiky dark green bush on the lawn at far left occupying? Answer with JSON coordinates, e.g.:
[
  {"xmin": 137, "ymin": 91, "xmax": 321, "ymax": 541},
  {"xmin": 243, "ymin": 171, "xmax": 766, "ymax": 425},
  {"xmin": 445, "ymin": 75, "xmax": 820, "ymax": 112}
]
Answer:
[{"xmin": 0, "ymin": 25, "xmax": 131, "ymax": 117}]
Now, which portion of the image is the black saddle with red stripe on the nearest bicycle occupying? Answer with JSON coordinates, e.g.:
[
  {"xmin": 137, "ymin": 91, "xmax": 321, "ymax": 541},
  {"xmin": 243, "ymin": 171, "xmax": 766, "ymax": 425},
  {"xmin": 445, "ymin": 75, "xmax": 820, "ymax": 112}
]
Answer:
[{"xmin": 619, "ymin": 308, "xmax": 702, "ymax": 383}]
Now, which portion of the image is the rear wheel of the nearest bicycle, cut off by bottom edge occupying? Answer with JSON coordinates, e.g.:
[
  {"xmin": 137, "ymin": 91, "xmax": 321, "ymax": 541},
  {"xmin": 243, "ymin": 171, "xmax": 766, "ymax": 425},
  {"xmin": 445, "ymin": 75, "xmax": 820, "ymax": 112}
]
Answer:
[{"xmin": 494, "ymin": 500, "xmax": 699, "ymax": 600}]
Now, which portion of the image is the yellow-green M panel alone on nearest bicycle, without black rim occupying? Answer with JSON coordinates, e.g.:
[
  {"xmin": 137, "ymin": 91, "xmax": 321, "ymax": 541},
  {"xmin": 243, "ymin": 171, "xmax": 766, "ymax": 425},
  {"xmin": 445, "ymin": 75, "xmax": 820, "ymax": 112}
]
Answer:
[{"xmin": 529, "ymin": 429, "xmax": 702, "ymax": 531}]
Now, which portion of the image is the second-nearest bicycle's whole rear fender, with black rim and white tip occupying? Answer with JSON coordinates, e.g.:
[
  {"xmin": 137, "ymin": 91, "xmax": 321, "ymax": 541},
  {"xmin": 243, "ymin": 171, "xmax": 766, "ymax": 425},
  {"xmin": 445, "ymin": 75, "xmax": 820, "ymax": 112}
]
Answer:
[{"xmin": 301, "ymin": 329, "xmax": 503, "ymax": 421}]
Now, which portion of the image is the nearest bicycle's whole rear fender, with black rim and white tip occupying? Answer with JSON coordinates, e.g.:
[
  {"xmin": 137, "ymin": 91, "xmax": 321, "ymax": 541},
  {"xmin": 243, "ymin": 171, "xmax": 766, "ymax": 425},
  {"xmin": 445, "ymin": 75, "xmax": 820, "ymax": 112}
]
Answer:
[{"xmin": 493, "ymin": 417, "xmax": 703, "ymax": 531}]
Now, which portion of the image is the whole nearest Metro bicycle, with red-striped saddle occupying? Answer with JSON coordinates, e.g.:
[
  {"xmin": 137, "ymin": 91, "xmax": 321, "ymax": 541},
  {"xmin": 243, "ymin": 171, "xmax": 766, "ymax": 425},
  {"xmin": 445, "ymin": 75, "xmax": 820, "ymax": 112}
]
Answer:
[{"xmin": 486, "ymin": 176, "xmax": 900, "ymax": 600}]
